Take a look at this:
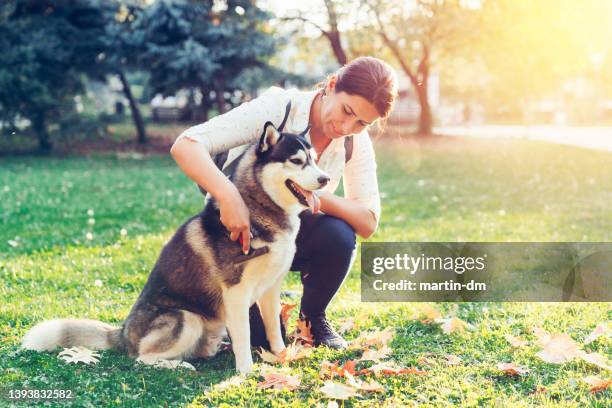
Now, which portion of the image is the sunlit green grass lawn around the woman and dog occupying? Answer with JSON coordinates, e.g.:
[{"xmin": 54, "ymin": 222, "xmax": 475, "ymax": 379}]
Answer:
[{"xmin": 0, "ymin": 139, "xmax": 612, "ymax": 407}]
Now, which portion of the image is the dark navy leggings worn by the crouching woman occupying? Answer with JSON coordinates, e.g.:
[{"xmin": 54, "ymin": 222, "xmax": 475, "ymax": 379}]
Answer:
[{"xmin": 249, "ymin": 211, "xmax": 356, "ymax": 336}]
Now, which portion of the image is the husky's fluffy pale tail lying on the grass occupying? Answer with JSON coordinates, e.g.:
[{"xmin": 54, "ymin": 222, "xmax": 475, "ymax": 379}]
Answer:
[{"xmin": 21, "ymin": 319, "xmax": 121, "ymax": 351}]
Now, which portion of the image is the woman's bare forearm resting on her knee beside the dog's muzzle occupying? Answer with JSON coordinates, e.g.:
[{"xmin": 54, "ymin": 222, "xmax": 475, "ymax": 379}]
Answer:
[{"xmin": 317, "ymin": 191, "xmax": 377, "ymax": 239}]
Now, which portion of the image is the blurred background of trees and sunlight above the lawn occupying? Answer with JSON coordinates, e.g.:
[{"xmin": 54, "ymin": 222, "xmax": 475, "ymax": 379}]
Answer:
[{"xmin": 0, "ymin": 0, "xmax": 612, "ymax": 154}]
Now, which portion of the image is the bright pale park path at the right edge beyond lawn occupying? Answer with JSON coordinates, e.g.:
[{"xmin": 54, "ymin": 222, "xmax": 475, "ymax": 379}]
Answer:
[{"xmin": 434, "ymin": 125, "xmax": 612, "ymax": 151}]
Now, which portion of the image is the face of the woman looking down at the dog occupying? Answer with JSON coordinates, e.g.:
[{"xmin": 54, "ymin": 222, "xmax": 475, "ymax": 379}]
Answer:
[{"xmin": 321, "ymin": 76, "xmax": 380, "ymax": 139}]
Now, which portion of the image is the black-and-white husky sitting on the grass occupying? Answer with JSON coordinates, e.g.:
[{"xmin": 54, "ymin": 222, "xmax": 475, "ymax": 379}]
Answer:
[{"xmin": 23, "ymin": 122, "xmax": 329, "ymax": 373}]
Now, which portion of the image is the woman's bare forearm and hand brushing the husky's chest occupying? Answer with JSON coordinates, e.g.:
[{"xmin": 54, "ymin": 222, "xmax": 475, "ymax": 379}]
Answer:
[{"xmin": 170, "ymin": 137, "xmax": 251, "ymax": 253}]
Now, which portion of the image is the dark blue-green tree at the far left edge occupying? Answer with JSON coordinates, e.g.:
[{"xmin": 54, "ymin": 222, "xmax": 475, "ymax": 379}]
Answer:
[{"xmin": 0, "ymin": 0, "xmax": 115, "ymax": 151}]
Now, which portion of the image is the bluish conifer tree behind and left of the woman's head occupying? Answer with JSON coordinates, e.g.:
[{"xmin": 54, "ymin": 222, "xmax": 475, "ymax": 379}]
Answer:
[{"xmin": 133, "ymin": 0, "xmax": 275, "ymax": 120}]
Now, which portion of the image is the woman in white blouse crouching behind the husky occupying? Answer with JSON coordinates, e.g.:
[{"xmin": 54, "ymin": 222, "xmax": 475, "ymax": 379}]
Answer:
[{"xmin": 170, "ymin": 57, "xmax": 397, "ymax": 348}]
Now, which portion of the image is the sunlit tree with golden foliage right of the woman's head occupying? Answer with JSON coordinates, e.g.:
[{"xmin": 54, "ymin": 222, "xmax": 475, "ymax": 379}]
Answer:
[{"xmin": 367, "ymin": 0, "xmax": 477, "ymax": 135}]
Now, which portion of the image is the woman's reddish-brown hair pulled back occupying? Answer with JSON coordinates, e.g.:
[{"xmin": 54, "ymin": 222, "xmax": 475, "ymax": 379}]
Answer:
[{"xmin": 317, "ymin": 57, "xmax": 397, "ymax": 120}]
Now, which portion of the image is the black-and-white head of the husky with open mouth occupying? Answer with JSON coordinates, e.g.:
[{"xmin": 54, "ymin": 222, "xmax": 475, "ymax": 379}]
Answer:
[{"xmin": 257, "ymin": 122, "xmax": 329, "ymax": 208}]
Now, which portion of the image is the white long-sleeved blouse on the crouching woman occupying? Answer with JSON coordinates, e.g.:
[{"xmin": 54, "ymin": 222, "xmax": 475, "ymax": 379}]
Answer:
[{"xmin": 177, "ymin": 86, "xmax": 380, "ymax": 222}]
